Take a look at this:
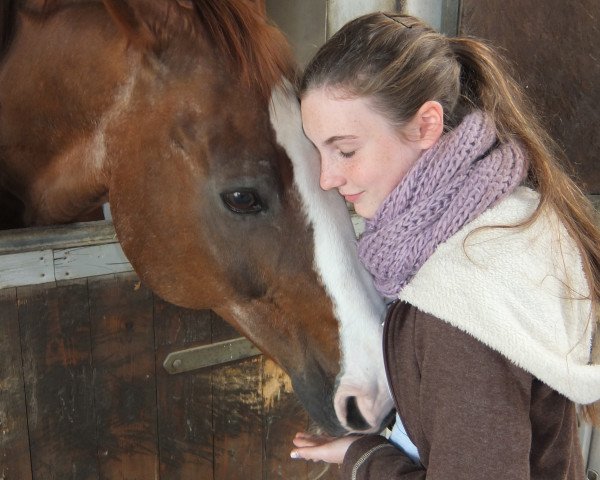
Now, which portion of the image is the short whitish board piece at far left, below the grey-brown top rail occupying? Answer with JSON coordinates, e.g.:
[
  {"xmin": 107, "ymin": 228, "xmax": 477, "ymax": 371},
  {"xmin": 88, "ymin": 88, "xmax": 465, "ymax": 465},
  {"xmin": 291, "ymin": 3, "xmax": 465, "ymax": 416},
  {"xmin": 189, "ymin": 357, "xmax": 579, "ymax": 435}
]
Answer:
[{"xmin": 0, "ymin": 250, "xmax": 55, "ymax": 288}]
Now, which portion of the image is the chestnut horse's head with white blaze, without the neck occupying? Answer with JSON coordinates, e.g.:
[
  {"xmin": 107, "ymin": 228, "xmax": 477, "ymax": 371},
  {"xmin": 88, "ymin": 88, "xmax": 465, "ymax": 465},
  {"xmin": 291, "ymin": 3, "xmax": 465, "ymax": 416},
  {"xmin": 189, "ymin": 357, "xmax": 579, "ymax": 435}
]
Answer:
[{"xmin": 0, "ymin": 0, "xmax": 392, "ymax": 434}]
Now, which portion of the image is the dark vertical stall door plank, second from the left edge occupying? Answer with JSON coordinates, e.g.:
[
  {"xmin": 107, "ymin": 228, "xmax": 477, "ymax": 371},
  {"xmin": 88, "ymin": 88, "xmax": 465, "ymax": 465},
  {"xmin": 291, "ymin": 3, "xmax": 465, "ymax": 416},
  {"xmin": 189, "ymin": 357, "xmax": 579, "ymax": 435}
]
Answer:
[{"xmin": 17, "ymin": 280, "xmax": 98, "ymax": 480}]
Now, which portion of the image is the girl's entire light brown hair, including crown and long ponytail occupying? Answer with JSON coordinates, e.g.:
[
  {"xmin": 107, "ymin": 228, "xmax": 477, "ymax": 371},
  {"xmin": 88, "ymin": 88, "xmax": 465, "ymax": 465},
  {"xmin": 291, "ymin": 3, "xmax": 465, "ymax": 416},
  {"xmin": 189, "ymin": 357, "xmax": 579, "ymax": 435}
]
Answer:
[{"xmin": 299, "ymin": 13, "xmax": 600, "ymax": 424}]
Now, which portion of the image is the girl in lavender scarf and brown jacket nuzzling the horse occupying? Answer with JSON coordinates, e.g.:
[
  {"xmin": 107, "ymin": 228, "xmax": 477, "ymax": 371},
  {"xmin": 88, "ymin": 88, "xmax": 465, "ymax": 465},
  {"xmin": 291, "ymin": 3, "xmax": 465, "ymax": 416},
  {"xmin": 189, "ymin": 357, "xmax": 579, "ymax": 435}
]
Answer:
[{"xmin": 292, "ymin": 13, "xmax": 600, "ymax": 480}]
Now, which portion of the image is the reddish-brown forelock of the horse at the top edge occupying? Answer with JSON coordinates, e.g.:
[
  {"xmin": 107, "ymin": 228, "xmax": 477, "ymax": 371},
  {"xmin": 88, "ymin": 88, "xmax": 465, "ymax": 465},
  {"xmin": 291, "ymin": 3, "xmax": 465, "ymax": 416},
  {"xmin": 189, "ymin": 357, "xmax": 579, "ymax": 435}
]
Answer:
[{"xmin": 193, "ymin": 0, "xmax": 296, "ymax": 98}]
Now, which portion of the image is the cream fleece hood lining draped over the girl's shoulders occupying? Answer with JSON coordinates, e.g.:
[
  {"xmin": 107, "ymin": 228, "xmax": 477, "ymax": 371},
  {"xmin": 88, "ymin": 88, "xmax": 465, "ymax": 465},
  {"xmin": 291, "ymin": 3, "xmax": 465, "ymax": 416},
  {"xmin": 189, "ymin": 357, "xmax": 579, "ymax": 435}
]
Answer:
[{"xmin": 399, "ymin": 187, "xmax": 600, "ymax": 404}]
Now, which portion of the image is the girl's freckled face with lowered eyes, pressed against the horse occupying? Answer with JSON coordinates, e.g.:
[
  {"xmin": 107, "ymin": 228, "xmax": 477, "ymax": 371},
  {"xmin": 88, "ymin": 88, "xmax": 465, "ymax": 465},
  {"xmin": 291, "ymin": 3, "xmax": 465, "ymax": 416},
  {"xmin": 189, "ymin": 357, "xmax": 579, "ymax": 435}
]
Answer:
[{"xmin": 302, "ymin": 88, "xmax": 422, "ymax": 218}]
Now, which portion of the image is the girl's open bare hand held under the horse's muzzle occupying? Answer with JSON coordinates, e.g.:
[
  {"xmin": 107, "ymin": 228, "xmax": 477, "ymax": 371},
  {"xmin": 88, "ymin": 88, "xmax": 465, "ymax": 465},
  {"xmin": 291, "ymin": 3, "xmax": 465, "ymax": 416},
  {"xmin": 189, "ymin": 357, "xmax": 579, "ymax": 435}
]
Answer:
[{"xmin": 290, "ymin": 432, "xmax": 360, "ymax": 463}]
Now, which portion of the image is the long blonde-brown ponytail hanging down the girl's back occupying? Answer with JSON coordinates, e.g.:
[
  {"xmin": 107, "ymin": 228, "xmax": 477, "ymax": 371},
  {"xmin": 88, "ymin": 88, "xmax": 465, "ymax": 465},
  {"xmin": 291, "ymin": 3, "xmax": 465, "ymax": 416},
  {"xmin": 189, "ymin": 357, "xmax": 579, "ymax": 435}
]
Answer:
[{"xmin": 449, "ymin": 37, "xmax": 600, "ymax": 425}]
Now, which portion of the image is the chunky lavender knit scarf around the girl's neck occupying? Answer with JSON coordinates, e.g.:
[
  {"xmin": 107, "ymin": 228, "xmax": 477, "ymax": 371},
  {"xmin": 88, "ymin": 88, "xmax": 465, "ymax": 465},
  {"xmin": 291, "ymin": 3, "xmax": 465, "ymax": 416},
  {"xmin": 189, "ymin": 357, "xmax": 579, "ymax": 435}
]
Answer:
[{"xmin": 358, "ymin": 111, "xmax": 527, "ymax": 297}]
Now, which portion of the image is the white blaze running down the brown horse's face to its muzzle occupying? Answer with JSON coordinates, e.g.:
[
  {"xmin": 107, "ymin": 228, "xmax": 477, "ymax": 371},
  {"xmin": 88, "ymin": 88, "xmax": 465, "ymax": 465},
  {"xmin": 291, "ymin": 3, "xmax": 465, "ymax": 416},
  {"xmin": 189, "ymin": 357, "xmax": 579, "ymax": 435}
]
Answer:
[{"xmin": 270, "ymin": 79, "xmax": 393, "ymax": 432}]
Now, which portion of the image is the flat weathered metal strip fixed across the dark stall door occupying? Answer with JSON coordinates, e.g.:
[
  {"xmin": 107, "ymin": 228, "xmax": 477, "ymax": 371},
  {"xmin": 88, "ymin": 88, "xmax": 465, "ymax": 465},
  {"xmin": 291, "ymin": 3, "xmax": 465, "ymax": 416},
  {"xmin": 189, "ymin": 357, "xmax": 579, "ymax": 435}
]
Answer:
[{"xmin": 163, "ymin": 337, "xmax": 261, "ymax": 375}]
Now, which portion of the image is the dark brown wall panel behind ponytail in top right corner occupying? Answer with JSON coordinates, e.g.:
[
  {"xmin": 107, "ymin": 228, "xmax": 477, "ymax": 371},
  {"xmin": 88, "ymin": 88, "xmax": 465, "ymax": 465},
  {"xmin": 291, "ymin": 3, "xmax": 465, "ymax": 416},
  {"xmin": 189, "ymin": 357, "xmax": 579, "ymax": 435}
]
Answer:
[{"xmin": 461, "ymin": 0, "xmax": 600, "ymax": 194}]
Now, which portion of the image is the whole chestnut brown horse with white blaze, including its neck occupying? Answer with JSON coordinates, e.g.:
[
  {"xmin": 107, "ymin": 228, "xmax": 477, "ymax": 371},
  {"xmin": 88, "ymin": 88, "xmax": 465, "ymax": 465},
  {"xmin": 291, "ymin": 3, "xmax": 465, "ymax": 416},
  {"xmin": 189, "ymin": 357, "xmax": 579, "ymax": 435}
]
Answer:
[{"xmin": 0, "ymin": 0, "xmax": 392, "ymax": 435}]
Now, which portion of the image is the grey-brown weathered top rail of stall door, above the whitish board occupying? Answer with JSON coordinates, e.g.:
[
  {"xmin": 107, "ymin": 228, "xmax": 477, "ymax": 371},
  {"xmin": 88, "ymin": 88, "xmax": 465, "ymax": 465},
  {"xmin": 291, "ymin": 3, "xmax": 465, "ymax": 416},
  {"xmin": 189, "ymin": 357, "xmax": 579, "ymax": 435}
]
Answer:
[{"xmin": 0, "ymin": 220, "xmax": 117, "ymax": 255}]
